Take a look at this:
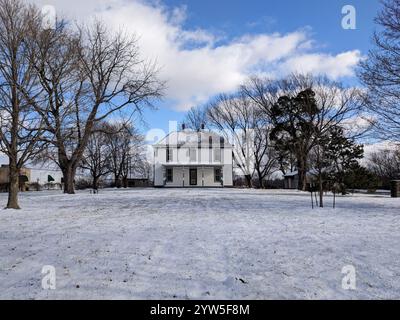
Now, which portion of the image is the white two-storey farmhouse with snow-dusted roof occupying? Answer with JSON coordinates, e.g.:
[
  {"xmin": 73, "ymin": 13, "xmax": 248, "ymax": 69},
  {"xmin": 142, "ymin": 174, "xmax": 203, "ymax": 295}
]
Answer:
[{"xmin": 153, "ymin": 129, "xmax": 233, "ymax": 188}]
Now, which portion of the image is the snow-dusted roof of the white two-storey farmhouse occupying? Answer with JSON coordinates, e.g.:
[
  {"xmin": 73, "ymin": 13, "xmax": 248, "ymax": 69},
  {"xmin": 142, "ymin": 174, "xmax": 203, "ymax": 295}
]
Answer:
[{"xmin": 154, "ymin": 130, "xmax": 232, "ymax": 148}]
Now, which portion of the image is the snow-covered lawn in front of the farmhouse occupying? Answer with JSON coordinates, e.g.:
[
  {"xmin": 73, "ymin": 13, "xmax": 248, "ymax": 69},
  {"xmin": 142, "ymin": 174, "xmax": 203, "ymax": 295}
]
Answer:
[{"xmin": 0, "ymin": 189, "xmax": 400, "ymax": 299}]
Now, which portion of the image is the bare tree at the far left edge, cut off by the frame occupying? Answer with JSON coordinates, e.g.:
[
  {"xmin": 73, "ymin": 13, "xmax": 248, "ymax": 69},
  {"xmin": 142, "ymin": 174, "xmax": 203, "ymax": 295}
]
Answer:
[{"xmin": 0, "ymin": 0, "xmax": 43, "ymax": 209}]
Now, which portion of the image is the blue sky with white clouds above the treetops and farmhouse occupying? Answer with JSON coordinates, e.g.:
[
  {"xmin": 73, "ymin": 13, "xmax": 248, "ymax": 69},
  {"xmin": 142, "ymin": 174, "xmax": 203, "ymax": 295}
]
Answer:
[{"xmin": 0, "ymin": 0, "xmax": 380, "ymax": 166}]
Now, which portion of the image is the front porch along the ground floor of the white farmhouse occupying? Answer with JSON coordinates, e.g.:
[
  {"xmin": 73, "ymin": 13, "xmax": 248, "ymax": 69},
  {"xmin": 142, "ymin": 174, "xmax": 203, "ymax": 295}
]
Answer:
[{"xmin": 163, "ymin": 164, "xmax": 224, "ymax": 188}]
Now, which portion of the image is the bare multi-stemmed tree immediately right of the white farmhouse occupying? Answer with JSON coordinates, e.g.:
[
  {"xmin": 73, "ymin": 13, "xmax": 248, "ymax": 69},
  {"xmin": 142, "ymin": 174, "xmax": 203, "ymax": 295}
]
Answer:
[{"xmin": 205, "ymin": 85, "xmax": 278, "ymax": 188}]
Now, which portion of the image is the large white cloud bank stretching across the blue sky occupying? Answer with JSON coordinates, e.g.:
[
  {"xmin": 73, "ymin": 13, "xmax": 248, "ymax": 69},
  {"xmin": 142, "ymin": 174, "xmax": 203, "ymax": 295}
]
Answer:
[{"xmin": 28, "ymin": 0, "xmax": 361, "ymax": 110}]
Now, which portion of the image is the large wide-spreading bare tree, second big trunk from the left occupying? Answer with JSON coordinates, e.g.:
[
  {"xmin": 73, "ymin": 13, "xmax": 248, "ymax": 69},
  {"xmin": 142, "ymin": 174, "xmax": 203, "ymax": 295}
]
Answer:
[{"xmin": 28, "ymin": 22, "xmax": 164, "ymax": 194}]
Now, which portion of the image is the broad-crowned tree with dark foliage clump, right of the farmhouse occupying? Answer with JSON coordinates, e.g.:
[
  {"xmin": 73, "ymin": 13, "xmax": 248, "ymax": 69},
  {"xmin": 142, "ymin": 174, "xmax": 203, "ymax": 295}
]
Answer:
[{"xmin": 244, "ymin": 74, "xmax": 368, "ymax": 190}]
